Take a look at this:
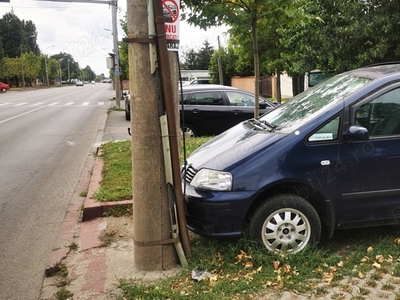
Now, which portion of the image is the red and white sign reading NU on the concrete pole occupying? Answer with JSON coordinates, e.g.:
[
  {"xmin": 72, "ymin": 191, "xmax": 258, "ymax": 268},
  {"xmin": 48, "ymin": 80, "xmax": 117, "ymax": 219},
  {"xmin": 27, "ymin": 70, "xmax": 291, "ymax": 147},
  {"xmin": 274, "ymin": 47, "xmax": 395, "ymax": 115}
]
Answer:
[{"xmin": 162, "ymin": 0, "xmax": 180, "ymax": 51}]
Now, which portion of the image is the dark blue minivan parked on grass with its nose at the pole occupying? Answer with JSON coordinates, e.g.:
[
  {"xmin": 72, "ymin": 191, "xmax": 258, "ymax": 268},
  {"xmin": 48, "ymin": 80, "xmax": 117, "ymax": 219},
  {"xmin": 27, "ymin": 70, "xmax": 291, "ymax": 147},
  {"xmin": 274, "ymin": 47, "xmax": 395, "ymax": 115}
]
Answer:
[{"xmin": 182, "ymin": 64, "xmax": 400, "ymax": 253}]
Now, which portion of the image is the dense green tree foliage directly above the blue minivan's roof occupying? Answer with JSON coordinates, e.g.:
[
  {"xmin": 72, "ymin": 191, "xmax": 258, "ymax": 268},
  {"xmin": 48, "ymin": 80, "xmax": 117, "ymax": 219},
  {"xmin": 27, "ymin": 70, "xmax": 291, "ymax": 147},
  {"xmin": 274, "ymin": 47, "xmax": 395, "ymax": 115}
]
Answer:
[{"xmin": 281, "ymin": 0, "xmax": 400, "ymax": 73}]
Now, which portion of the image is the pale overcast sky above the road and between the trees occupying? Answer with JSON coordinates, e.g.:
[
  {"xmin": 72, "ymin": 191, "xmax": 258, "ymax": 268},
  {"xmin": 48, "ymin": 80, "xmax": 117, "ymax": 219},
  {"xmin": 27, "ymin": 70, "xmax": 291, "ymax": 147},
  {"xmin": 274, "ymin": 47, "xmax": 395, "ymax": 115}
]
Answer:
[{"xmin": 0, "ymin": 0, "xmax": 227, "ymax": 75}]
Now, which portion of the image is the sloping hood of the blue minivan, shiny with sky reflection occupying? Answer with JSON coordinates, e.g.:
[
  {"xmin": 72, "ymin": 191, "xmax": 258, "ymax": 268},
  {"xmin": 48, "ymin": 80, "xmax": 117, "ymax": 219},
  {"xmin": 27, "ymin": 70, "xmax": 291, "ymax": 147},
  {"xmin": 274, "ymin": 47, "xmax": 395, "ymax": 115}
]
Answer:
[{"xmin": 187, "ymin": 123, "xmax": 287, "ymax": 171}]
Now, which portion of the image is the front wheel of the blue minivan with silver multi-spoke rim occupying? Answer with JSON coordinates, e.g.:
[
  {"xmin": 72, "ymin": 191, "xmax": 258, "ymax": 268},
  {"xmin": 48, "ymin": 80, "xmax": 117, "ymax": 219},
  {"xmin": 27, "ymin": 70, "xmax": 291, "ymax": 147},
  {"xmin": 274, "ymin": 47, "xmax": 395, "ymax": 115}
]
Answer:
[{"xmin": 249, "ymin": 194, "xmax": 321, "ymax": 254}]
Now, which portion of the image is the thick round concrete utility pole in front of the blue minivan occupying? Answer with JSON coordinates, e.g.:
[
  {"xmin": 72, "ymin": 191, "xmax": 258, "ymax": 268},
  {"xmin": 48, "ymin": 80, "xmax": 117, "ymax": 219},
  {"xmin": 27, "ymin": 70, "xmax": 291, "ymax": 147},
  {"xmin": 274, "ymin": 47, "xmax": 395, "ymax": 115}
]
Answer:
[{"xmin": 127, "ymin": 0, "xmax": 178, "ymax": 270}]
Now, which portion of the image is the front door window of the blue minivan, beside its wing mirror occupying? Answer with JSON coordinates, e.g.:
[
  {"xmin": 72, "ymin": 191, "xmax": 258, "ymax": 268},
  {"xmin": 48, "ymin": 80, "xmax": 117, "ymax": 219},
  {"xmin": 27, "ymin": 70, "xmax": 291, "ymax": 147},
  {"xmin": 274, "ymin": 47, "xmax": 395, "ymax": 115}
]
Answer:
[{"xmin": 355, "ymin": 89, "xmax": 400, "ymax": 138}]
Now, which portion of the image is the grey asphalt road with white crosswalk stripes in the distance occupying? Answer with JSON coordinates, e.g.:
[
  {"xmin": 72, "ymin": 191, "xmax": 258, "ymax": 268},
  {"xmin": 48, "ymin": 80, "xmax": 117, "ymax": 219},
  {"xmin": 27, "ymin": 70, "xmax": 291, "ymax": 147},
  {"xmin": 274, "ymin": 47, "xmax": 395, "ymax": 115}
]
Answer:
[{"xmin": 0, "ymin": 83, "xmax": 114, "ymax": 300}]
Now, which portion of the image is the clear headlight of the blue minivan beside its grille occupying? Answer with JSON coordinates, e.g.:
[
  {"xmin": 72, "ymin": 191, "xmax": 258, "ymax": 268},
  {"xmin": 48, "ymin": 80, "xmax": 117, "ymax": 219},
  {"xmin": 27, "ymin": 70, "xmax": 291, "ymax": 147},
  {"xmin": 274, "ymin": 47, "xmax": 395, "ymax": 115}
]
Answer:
[{"xmin": 190, "ymin": 169, "xmax": 232, "ymax": 191}]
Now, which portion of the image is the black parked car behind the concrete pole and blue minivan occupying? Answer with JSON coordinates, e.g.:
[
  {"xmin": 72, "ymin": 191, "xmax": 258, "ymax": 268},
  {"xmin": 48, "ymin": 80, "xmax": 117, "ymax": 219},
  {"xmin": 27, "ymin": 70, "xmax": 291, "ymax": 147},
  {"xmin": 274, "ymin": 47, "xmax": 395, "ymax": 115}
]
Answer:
[{"xmin": 125, "ymin": 84, "xmax": 275, "ymax": 136}]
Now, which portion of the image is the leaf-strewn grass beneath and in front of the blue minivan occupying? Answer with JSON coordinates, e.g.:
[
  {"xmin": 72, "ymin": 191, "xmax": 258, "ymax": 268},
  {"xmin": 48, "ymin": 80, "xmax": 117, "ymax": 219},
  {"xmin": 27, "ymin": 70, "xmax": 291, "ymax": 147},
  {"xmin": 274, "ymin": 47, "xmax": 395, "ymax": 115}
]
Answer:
[{"xmin": 119, "ymin": 227, "xmax": 400, "ymax": 300}]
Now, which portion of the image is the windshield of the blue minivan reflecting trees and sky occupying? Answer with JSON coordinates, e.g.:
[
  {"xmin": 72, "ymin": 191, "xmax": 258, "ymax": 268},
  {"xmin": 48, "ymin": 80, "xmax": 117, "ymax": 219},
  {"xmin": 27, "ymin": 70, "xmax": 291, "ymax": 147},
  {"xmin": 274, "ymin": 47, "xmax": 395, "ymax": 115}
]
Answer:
[{"xmin": 260, "ymin": 74, "xmax": 372, "ymax": 133}]
